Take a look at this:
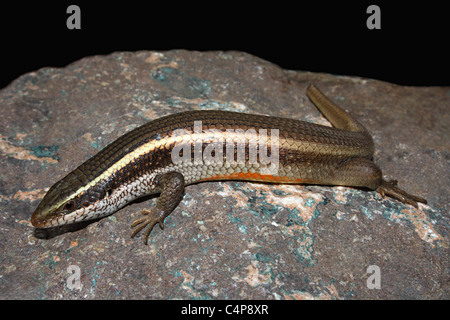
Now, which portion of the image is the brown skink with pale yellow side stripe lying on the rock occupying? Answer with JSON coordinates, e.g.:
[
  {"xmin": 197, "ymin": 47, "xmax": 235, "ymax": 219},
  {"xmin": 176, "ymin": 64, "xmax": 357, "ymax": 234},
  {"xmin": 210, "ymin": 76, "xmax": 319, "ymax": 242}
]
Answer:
[{"xmin": 31, "ymin": 86, "xmax": 426, "ymax": 243}]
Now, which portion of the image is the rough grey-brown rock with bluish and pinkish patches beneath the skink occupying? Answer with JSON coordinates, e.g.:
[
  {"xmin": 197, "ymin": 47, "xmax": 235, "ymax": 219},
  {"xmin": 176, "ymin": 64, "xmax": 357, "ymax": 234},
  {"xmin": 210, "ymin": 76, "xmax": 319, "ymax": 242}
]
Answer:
[{"xmin": 0, "ymin": 50, "xmax": 450, "ymax": 299}]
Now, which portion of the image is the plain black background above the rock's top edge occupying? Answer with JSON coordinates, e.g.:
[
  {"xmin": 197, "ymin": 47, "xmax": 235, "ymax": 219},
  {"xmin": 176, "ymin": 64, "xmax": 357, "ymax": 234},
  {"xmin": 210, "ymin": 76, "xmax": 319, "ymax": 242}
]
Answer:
[{"xmin": 0, "ymin": 1, "xmax": 450, "ymax": 88}]
